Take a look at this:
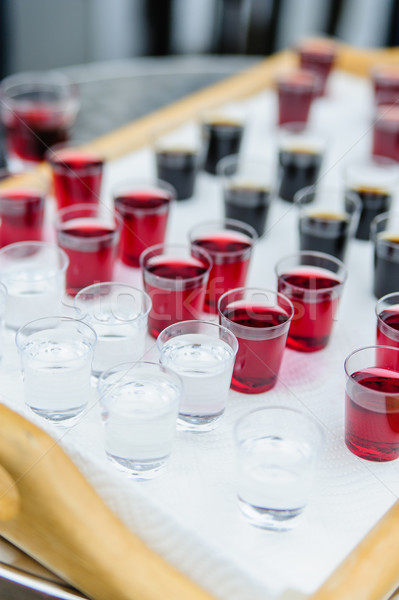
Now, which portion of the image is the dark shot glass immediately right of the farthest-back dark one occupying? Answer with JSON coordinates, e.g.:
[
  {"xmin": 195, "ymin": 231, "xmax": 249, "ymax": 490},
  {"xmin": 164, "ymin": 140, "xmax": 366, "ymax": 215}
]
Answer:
[{"xmin": 277, "ymin": 123, "xmax": 326, "ymax": 202}]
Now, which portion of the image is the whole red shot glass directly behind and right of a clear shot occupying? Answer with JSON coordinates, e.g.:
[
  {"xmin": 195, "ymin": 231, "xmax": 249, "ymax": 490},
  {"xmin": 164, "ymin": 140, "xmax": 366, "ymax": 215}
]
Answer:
[{"xmin": 218, "ymin": 288, "xmax": 294, "ymax": 394}]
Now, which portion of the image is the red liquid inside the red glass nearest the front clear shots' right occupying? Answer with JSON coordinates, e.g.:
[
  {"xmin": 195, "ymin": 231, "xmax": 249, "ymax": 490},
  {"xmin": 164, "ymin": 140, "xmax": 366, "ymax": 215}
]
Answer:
[{"xmin": 221, "ymin": 302, "xmax": 289, "ymax": 394}]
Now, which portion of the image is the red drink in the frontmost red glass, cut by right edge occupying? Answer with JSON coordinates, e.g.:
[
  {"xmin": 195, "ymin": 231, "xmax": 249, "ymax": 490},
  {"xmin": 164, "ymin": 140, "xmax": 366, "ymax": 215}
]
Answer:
[{"xmin": 345, "ymin": 367, "xmax": 399, "ymax": 461}]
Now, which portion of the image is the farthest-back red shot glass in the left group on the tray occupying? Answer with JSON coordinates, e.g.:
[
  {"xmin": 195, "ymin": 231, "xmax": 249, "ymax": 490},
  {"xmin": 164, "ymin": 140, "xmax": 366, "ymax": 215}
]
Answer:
[{"xmin": 45, "ymin": 142, "xmax": 104, "ymax": 209}]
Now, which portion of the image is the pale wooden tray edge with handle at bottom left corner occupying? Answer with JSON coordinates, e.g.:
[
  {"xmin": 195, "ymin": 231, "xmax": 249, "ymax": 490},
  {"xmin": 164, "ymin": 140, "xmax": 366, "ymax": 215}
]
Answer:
[{"xmin": 0, "ymin": 404, "xmax": 217, "ymax": 600}]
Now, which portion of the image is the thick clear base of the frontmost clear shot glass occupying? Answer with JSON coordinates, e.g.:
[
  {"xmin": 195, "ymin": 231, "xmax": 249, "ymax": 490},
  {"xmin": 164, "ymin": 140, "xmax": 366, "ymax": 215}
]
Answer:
[{"xmin": 238, "ymin": 497, "xmax": 304, "ymax": 531}]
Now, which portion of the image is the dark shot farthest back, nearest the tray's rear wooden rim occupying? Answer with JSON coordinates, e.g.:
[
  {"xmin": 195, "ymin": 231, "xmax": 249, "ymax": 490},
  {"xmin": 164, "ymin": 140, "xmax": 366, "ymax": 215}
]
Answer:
[{"xmin": 201, "ymin": 107, "xmax": 245, "ymax": 175}]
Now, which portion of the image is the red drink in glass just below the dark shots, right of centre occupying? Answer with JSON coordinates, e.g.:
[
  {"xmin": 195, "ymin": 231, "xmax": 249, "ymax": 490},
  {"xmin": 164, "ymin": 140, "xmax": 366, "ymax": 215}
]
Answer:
[{"xmin": 278, "ymin": 266, "xmax": 342, "ymax": 352}]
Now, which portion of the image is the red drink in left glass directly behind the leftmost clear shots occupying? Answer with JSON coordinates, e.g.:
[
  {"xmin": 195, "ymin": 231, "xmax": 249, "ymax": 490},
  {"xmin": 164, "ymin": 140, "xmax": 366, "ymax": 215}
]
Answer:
[{"xmin": 57, "ymin": 218, "xmax": 118, "ymax": 296}]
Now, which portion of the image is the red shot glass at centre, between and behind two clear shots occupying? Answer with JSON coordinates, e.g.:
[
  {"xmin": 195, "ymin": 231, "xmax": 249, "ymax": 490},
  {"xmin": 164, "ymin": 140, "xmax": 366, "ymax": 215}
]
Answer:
[{"xmin": 140, "ymin": 244, "xmax": 212, "ymax": 338}]
